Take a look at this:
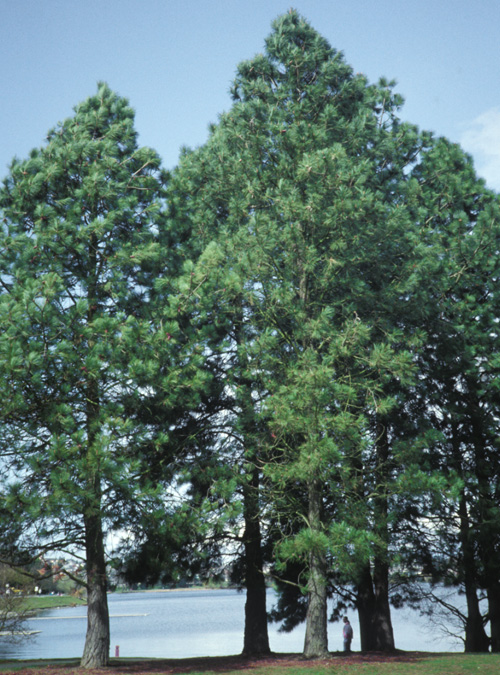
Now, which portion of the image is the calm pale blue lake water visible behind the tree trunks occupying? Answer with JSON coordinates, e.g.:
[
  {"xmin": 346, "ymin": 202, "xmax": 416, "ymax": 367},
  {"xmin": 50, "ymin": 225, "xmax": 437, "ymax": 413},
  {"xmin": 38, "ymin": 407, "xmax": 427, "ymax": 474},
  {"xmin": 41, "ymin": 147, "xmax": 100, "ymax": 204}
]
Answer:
[{"xmin": 0, "ymin": 590, "xmax": 463, "ymax": 659}]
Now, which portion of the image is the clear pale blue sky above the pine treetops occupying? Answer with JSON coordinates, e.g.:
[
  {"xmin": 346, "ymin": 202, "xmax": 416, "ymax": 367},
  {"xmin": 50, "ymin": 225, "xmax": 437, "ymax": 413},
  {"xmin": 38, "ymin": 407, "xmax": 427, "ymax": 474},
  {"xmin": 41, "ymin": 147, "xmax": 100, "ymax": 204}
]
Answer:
[{"xmin": 0, "ymin": 0, "xmax": 500, "ymax": 190}]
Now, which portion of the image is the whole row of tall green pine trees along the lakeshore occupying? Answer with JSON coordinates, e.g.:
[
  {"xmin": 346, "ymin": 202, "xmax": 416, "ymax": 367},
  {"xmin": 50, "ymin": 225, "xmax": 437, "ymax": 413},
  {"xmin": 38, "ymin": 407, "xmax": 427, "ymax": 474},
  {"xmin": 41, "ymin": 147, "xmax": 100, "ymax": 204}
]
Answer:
[{"xmin": 0, "ymin": 11, "xmax": 500, "ymax": 667}]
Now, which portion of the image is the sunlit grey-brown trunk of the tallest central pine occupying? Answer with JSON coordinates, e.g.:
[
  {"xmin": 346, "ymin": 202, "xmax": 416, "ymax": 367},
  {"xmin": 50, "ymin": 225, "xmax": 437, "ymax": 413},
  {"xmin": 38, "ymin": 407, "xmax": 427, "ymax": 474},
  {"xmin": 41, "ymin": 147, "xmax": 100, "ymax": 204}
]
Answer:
[{"xmin": 304, "ymin": 480, "xmax": 328, "ymax": 658}]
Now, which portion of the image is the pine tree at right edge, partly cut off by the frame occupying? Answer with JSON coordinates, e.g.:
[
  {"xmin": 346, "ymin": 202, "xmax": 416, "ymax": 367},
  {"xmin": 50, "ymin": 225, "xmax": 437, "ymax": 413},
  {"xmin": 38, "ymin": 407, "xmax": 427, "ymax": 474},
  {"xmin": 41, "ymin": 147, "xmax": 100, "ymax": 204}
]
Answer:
[{"xmin": 404, "ymin": 139, "xmax": 500, "ymax": 651}]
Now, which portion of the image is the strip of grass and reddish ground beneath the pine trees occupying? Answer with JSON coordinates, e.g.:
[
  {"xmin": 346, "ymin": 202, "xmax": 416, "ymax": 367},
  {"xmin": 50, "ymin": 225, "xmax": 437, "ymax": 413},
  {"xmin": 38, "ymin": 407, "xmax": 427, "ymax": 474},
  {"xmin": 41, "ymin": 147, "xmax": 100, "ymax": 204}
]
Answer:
[{"xmin": 0, "ymin": 652, "xmax": 500, "ymax": 675}]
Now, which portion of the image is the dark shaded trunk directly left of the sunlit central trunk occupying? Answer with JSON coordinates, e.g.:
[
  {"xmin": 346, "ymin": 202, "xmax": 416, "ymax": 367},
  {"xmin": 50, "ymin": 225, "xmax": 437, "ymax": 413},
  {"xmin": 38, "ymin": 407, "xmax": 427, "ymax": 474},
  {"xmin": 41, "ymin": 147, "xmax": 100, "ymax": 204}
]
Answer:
[{"xmin": 243, "ymin": 467, "xmax": 271, "ymax": 656}]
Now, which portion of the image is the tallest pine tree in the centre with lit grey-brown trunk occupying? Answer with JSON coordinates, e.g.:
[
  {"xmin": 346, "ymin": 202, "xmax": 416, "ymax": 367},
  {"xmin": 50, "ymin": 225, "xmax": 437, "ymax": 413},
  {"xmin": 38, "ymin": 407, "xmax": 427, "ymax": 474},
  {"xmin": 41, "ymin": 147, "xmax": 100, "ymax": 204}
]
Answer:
[{"xmin": 171, "ymin": 11, "xmax": 422, "ymax": 656}]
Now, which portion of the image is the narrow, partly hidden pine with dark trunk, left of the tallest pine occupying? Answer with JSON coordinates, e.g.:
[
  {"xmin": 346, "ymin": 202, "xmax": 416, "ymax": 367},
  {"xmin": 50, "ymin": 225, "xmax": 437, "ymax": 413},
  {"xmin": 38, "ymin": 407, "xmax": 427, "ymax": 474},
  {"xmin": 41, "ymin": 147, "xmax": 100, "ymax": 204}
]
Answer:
[{"xmin": 161, "ymin": 129, "xmax": 278, "ymax": 655}]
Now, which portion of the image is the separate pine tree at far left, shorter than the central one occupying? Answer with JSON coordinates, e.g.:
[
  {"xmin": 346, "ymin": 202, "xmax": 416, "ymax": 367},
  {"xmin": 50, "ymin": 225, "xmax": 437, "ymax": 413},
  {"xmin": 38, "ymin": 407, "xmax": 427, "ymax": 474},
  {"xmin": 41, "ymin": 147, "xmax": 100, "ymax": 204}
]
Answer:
[{"xmin": 0, "ymin": 84, "xmax": 168, "ymax": 668}]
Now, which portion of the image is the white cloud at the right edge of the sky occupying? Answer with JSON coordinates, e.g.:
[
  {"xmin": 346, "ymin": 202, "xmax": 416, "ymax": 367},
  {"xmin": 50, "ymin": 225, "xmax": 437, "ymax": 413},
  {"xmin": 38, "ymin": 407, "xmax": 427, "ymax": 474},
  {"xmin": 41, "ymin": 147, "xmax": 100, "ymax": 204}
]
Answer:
[{"xmin": 460, "ymin": 108, "xmax": 500, "ymax": 190}]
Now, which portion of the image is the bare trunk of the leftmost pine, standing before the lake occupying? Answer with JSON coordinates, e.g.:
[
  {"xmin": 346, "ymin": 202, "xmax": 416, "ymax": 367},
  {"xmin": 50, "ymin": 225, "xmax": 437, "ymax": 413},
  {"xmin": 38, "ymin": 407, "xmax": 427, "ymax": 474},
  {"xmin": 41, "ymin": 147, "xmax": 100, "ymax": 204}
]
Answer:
[{"xmin": 81, "ymin": 515, "xmax": 110, "ymax": 668}]
